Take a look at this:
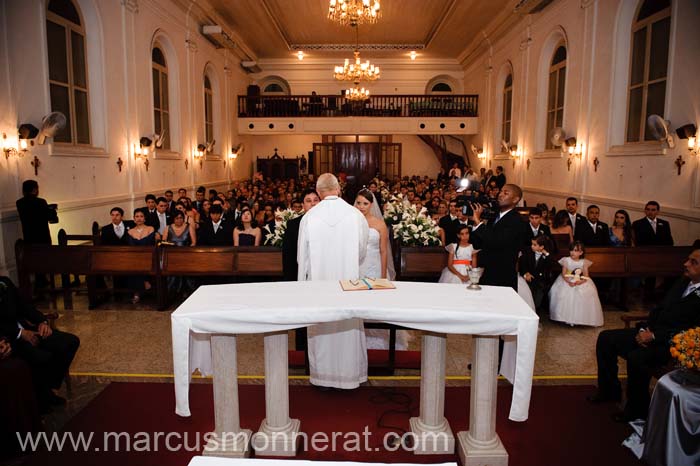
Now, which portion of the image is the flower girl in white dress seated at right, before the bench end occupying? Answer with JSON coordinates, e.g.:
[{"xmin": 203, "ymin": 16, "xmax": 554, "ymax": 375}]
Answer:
[{"xmin": 549, "ymin": 241, "xmax": 603, "ymax": 327}]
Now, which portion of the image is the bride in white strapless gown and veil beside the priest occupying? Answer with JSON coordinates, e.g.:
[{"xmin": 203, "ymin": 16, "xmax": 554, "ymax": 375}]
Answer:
[{"xmin": 355, "ymin": 189, "xmax": 409, "ymax": 350}]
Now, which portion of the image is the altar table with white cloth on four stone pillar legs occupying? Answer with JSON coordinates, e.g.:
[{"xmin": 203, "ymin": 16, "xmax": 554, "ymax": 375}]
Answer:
[{"xmin": 171, "ymin": 281, "xmax": 539, "ymax": 466}]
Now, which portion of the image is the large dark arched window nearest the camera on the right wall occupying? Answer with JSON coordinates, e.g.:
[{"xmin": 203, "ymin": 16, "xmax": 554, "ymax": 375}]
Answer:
[{"xmin": 627, "ymin": 0, "xmax": 671, "ymax": 142}]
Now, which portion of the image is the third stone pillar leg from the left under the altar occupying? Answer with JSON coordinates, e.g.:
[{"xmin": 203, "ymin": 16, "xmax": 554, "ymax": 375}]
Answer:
[{"xmin": 409, "ymin": 332, "xmax": 455, "ymax": 455}]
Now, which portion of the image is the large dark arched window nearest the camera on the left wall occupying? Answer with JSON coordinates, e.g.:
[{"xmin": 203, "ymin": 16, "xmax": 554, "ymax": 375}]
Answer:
[{"xmin": 46, "ymin": 0, "xmax": 91, "ymax": 145}]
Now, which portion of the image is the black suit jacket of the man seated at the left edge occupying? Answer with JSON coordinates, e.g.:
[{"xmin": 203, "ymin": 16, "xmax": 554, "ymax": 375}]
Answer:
[{"xmin": 0, "ymin": 276, "xmax": 46, "ymax": 343}]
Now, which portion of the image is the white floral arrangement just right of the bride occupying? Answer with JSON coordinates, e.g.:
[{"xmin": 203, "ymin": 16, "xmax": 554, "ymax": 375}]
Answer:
[{"xmin": 384, "ymin": 194, "xmax": 442, "ymax": 246}]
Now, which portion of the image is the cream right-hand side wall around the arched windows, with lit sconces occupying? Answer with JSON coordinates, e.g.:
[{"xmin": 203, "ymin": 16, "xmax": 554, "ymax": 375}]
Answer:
[{"xmin": 464, "ymin": 0, "xmax": 700, "ymax": 244}]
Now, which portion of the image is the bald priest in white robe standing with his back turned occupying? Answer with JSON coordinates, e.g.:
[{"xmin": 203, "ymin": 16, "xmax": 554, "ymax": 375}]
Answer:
[{"xmin": 297, "ymin": 173, "xmax": 369, "ymax": 389}]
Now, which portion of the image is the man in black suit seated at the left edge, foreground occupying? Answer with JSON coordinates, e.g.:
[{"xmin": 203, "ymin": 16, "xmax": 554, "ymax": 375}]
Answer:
[{"xmin": 0, "ymin": 277, "xmax": 80, "ymax": 412}]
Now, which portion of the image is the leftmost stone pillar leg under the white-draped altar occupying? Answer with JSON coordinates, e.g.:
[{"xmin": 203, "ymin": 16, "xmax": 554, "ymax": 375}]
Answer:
[{"xmin": 203, "ymin": 335, "xmax": 251, "ymax": 458}]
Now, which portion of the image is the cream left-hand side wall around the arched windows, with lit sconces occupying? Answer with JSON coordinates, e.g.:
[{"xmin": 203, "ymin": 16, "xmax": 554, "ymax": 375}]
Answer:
[{"xmin": 0, "ymin": 0, "xmax": 249, "ymax": 274}]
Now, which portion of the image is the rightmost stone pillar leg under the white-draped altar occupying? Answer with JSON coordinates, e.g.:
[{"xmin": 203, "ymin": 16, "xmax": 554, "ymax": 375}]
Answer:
[{"xmin": 457, "ymin": 335, "xmax": 508, "ymax": 466}]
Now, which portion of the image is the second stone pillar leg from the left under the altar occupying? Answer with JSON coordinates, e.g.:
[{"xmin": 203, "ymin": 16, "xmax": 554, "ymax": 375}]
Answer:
[{"xmin": 253, "ymin": 331, "xmax": 301, "ymax": 456}]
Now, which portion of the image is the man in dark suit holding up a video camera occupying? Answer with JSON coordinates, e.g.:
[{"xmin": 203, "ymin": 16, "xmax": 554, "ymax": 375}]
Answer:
[{"xmin": 471, "ymin": 184, "xmax": 527, "ymax": 290}]
